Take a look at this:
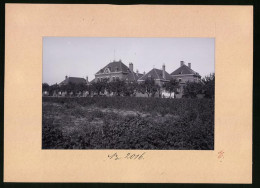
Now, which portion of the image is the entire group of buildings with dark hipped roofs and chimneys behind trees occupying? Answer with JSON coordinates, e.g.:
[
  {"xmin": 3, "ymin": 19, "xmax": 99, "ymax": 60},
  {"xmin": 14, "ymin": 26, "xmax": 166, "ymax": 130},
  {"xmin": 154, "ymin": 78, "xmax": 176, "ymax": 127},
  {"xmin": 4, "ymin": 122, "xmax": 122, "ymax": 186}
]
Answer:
[{"xmin": 52, "ymin": 60, "xmax": 201, "ymax": 98}]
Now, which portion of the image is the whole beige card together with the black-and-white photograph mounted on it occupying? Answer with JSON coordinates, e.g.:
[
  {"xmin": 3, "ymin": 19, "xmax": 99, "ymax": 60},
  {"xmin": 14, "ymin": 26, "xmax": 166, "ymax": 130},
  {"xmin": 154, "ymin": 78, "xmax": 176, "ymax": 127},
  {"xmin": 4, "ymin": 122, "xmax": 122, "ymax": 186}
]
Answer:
[{"xmin": 4, "ymin": 4, "xmax": 253, "ymax": 183}]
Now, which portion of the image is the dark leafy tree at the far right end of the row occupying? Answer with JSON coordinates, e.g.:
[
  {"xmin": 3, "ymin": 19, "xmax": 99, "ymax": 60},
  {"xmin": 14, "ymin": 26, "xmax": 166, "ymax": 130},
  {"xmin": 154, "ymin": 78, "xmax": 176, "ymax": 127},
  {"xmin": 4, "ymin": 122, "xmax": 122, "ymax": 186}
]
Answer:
[{"xmin": 202, "ymin": 73, "xmax": 215, "ymax": 98}]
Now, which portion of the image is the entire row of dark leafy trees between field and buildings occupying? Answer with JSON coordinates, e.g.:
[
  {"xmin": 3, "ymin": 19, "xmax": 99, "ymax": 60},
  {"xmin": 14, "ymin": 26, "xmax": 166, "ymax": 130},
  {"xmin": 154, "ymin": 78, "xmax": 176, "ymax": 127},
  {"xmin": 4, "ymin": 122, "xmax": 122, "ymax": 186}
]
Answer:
[{"xmin": 42, "ymin": 74, "xmax": 215, "ymax": 98}]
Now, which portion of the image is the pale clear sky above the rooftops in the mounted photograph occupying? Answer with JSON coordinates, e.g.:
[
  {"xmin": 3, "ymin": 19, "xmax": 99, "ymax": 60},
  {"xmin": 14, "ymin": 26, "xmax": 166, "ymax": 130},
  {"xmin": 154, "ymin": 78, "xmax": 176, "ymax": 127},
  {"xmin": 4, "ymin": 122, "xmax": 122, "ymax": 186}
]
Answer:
[{"xmin": 43, "ymin": 37, "xmax": 215, "ymax": 85}]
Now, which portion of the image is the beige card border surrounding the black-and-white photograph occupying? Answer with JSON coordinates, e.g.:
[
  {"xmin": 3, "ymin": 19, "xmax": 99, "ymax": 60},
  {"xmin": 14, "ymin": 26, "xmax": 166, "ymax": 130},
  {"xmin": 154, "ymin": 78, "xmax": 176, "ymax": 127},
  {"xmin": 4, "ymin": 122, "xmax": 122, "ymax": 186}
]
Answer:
[{"xmin": 4, "ymin": 4, "xmax": 253, "ymax": 183}]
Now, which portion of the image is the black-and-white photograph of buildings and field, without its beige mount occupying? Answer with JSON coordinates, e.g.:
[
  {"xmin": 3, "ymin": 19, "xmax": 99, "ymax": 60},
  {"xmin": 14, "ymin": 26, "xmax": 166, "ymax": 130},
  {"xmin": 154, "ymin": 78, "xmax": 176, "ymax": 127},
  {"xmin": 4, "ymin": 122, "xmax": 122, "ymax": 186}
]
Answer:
[{"xmin": 42, "ymin": 37, "xmax": 215, "ymax": 150}]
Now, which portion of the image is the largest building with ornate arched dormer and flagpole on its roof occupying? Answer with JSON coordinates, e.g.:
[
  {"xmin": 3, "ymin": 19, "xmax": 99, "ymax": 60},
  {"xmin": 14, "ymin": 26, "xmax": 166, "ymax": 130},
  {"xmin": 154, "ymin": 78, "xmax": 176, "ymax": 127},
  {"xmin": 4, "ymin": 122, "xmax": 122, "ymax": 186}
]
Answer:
[{"xmin": 94, "ymin": 60, "xmax": 143, "ymax": 82}]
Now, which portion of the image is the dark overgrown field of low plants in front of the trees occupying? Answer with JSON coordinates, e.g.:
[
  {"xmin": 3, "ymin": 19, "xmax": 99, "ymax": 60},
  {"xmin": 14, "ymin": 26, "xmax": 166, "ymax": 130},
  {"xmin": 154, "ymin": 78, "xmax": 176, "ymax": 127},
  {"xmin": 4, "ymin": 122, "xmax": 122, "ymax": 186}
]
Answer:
[{"xmin": 42, "ymin": 97, "xmax": 214, "ymax": 150}]
